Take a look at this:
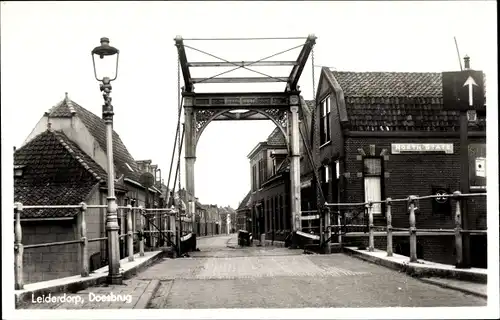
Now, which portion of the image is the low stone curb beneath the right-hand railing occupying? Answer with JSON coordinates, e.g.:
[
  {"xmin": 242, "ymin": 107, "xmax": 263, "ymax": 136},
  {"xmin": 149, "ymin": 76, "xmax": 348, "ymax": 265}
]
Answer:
[{"xmin": 343, "ymin": 247, "xmax": 488, "ymax": 284}]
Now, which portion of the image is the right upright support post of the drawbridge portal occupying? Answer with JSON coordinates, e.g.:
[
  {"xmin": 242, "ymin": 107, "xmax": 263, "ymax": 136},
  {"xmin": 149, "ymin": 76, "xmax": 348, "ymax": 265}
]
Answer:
[{"xmin": 288, "ymin": 95, "xmax": 302, "ymax": 232}]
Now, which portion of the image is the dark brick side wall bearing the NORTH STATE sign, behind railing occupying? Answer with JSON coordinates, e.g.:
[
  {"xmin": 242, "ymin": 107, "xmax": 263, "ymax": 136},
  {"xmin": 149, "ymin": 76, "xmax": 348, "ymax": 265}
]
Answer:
[{"xmin": 345, "ymin": 137, "xmax": 486, "ymax": 266}]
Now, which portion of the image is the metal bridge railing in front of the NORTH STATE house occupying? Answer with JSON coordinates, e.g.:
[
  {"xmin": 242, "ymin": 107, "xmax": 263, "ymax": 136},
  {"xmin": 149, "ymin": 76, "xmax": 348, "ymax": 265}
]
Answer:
[{"xmin": 325, "ymin": 191, "xmax": 487, "ymax": 265}]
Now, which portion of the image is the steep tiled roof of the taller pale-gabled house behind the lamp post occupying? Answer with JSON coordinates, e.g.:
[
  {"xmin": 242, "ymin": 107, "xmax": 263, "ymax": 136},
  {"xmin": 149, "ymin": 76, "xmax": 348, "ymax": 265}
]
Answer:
[{"xmin": 47, "ymin": 96, "xmax": 140, "ymax": 182}]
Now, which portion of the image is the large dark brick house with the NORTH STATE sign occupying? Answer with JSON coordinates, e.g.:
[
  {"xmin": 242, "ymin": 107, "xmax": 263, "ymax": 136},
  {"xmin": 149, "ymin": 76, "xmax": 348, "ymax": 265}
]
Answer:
[{"xmin": 313, "ymin": 68, "xmax": 486, "ymax": 267}]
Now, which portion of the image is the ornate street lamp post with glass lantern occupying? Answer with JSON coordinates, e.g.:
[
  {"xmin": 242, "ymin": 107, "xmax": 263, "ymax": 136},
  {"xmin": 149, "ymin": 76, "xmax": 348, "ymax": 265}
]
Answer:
[{"xmin": 92, "ymin": 38, "xmax": 122, "ymax": 284}]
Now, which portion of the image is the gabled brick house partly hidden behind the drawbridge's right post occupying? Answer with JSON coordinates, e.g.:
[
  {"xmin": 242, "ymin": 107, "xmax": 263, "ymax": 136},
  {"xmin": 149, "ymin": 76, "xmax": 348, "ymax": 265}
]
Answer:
[{"xmin": 239, "ymin": 97, "xmax": 315, "ymax": 241}]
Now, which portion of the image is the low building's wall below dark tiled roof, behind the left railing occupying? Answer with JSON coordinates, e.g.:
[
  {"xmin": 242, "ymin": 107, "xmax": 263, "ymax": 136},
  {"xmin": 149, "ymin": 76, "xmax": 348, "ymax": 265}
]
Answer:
[{"xmin": 21, "ymin": 220, "xmax": 80, "ymax": 284}]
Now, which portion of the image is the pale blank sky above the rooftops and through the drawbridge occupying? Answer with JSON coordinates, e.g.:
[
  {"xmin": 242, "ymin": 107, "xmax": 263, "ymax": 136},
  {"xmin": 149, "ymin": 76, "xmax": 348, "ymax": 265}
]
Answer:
[{"xmin": 1, "ymin": 1, "xmax": 497, "ymax": 207}]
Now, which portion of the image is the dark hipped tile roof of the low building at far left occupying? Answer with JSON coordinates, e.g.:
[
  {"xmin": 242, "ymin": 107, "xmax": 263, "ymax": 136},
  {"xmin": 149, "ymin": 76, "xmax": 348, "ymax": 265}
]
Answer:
[{"xmin": 14, "ymin": 130, "xmax": 106, "ymax": 218}]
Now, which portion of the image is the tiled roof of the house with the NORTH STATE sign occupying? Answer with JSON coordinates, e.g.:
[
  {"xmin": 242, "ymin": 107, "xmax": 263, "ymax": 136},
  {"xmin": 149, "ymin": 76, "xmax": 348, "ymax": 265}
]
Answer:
[{"xmin": 332, "ymin": 71, "xmax": 486, "ymax": 131}]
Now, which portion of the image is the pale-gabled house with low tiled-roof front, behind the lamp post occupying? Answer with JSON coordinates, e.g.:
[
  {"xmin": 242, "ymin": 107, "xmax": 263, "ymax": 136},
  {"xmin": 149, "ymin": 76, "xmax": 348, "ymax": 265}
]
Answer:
[{"xmin": 14, "ymin": 95, "xmax": 161, "ymax": 283}]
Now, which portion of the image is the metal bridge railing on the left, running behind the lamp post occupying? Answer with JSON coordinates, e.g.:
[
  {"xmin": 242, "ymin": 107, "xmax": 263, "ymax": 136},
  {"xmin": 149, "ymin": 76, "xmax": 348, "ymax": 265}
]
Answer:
[{"xmin": 14, "ymin": 202, "xmax": 178, "ymax": 290}]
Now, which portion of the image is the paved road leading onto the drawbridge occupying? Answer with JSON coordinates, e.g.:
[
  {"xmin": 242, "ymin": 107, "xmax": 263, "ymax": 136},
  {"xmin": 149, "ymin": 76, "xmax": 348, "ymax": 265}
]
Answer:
[{"xmin": 144, "ymin": 236, "xmax": 486, "ymax": 309}]
